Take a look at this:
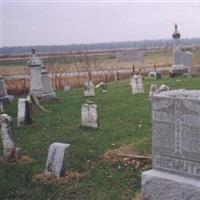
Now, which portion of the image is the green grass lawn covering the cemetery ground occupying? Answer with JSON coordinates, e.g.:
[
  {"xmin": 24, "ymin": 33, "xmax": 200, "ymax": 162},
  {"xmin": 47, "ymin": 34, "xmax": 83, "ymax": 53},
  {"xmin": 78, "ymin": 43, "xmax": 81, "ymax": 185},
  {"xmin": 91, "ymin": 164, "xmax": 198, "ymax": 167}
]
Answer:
[{"xmin": 0, "ymin": 77, "xmax": 200, "ymax": 200}]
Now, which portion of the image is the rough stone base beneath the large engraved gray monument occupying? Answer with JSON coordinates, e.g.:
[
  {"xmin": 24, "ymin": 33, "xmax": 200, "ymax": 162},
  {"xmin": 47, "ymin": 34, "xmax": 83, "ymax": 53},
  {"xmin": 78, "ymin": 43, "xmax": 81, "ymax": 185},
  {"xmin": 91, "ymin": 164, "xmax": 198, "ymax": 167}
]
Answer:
[{"xmin": 142, "ymin": 170, "xmax": 200, "ymax": 200}]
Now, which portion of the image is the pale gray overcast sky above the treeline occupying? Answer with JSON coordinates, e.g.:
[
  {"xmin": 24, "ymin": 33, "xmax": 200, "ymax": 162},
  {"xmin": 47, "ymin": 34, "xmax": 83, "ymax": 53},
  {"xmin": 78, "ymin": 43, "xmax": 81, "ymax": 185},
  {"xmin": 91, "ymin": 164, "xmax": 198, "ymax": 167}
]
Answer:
[{"xmin": 0, "ymin": 0, "xmax": 200, "ymax": 46}]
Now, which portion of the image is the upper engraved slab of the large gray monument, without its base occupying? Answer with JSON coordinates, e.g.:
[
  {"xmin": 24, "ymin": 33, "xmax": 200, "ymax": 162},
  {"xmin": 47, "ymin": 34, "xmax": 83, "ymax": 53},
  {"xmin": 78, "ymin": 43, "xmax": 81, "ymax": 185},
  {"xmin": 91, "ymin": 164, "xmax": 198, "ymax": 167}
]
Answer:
[{"xmin": 152, "ymin": 90, "xmax": 200, "ymax": 179}]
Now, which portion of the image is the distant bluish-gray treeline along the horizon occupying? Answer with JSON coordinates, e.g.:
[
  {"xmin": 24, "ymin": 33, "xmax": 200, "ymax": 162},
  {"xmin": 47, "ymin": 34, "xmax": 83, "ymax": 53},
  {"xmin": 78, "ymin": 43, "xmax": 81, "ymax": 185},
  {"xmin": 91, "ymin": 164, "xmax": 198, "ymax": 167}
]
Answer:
[{"xmin": 0, "ymin": 38, "xmax": 200, "ymax": 56}]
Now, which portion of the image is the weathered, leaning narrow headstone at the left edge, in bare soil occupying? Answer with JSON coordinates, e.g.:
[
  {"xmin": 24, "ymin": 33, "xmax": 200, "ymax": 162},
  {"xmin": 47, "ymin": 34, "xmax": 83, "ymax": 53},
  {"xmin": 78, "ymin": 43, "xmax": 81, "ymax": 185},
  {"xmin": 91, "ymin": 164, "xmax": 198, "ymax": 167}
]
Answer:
[{"xmin": 0, "ymin": 114, "xmax": 19, "ymax": 161}]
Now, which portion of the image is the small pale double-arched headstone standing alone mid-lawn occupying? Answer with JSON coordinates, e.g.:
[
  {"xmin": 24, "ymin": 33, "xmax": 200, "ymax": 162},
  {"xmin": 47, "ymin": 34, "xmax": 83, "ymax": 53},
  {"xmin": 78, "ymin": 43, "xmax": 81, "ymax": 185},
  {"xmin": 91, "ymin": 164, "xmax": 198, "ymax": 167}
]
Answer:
[{"xmin": 81, "ymin": 103, "xmax": 98, "ymax": 128}]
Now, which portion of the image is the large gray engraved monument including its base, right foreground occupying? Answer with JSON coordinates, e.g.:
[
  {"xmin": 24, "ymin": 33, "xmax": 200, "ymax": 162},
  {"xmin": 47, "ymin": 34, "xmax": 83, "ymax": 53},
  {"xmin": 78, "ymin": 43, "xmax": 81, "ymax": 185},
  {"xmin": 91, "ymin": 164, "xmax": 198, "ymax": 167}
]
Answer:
[{"xmin": 142, "ymin": 90, "xmax": 200, "ymax": 200}]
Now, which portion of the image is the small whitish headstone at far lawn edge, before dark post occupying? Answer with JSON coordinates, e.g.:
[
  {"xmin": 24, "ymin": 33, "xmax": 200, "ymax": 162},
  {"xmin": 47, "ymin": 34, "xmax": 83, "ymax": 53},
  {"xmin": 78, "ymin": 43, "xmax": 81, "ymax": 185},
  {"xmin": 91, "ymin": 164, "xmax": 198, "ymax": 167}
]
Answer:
[{"xmin": 130, "ymin": 75, "xmax": 144, "ymax": 94}]
